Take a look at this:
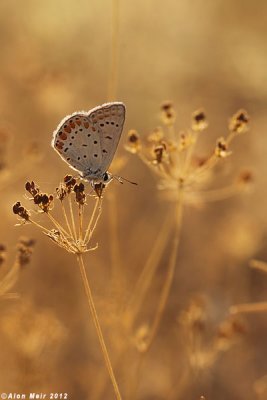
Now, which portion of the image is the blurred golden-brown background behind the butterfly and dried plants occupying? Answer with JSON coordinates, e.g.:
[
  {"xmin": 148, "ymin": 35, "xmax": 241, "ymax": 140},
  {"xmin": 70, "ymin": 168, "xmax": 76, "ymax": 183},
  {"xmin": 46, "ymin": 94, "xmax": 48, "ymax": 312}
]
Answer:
[{"xmin": 0, "ymin": 0, "xmax": 267, "ymax": 400}]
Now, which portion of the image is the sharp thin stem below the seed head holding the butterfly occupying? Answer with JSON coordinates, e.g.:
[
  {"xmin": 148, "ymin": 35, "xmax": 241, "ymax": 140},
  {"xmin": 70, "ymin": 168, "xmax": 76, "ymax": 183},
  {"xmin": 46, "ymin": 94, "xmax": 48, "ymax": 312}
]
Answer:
[{"xmin": 77, "ymin": 253, "xmax": 121, "ymax": 400}]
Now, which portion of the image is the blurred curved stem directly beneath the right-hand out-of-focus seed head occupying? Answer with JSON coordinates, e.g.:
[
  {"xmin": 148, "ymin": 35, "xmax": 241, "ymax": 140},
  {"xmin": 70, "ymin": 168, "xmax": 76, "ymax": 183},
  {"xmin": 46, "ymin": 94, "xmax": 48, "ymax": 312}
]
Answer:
[{"xmin": 144, "ymin": 189, "xmax": 183, "ymax": 351}]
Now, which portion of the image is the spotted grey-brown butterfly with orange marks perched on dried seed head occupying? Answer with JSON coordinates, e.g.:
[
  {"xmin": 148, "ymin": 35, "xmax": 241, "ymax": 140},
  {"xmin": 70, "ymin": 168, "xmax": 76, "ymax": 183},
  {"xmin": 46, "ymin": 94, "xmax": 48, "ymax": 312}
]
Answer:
[{"xmin": 51, "ymin": 102, "xmax": 126, "ymax": 185}]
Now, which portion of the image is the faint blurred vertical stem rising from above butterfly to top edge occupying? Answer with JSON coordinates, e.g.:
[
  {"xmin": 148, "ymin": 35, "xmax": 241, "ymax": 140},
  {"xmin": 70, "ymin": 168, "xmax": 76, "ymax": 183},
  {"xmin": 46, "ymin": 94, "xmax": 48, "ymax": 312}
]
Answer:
[{"xmin": 108, "ymin": 0, "xmax": 119, "ymax": 101}]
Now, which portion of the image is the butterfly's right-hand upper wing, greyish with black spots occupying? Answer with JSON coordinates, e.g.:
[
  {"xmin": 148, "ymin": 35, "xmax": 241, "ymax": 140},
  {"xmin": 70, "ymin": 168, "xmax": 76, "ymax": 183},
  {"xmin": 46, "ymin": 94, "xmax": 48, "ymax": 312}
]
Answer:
[{"xmin": 88, "ymin": 102, "xmax": 125, "ymax": 174}]
